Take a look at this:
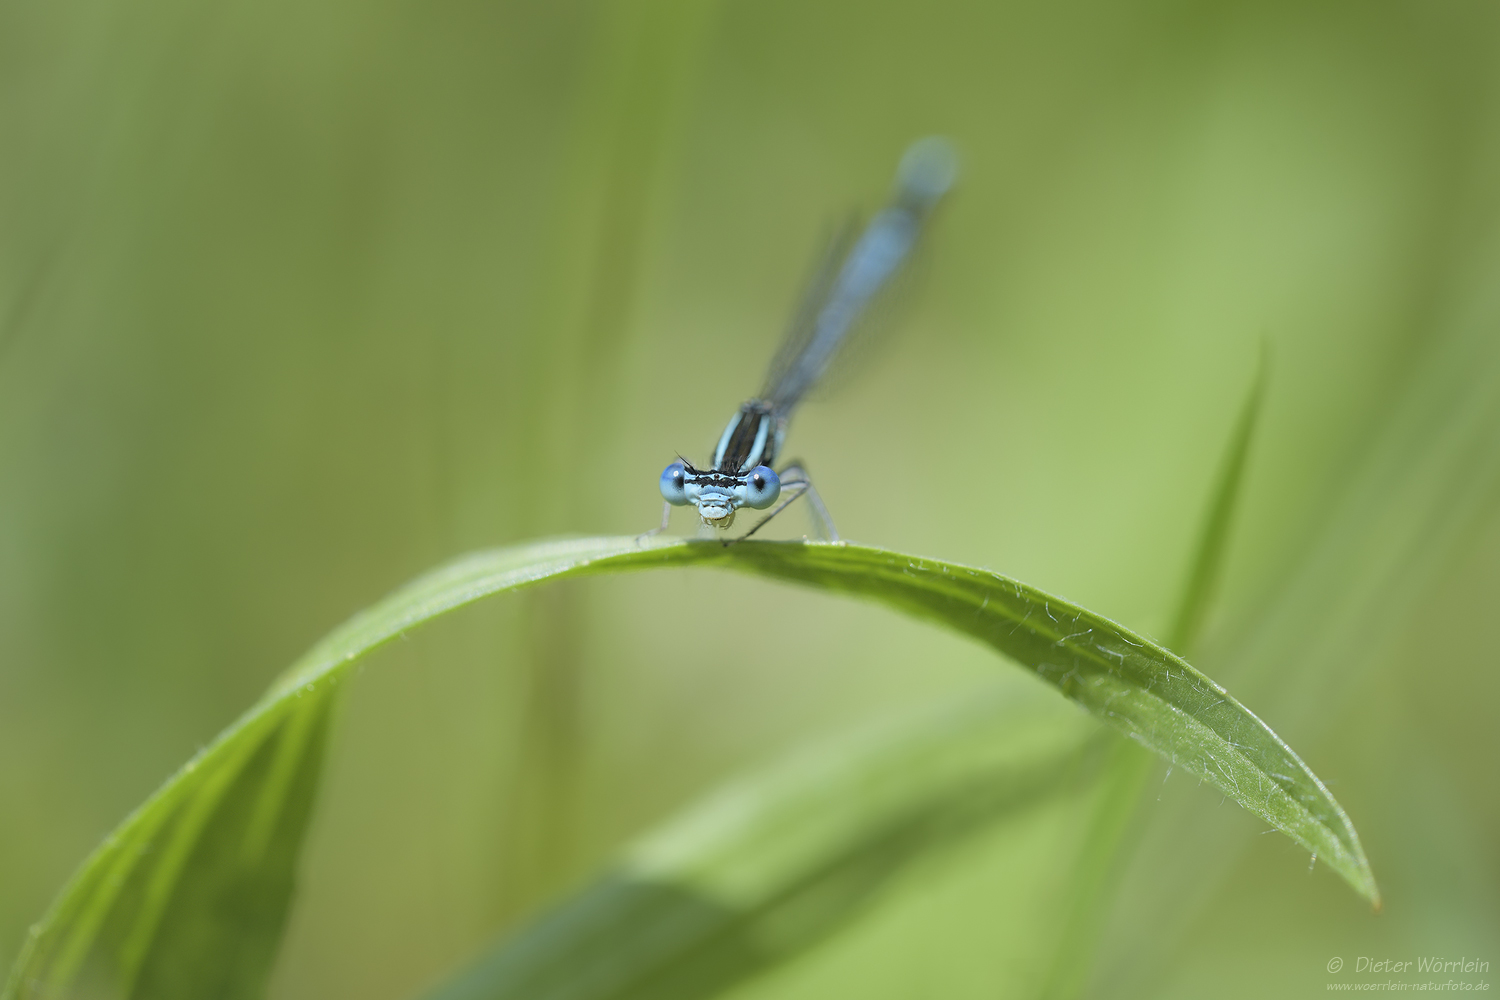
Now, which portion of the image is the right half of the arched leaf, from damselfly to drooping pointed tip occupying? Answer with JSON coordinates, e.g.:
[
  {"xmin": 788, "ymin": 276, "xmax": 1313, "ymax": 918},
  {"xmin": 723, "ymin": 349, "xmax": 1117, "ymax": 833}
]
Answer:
[{"xmin": 714, "ymin": 544, "xmax": 1380, "ymax": 907}]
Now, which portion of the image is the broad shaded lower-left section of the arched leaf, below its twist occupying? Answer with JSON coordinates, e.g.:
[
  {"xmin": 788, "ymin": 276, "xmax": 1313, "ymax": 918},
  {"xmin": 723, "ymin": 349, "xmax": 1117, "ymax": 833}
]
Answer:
[{"xmin": 5, "ymin": 687, "xmax": 333, "ymax": 999}]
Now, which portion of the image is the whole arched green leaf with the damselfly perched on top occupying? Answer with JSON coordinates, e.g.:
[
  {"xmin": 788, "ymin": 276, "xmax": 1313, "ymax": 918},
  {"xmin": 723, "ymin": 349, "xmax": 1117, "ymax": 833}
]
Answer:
[{"xmin": 5, "ymin": 538, "xmax": 1377, "ymax": 999}]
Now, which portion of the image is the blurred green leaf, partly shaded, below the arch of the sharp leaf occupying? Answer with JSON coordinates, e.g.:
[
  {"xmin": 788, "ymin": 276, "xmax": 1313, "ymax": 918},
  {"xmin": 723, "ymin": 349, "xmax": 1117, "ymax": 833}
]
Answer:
[{"xmin": 428, "ymin": 691, "xmax": 1104, "ymax": 1000}]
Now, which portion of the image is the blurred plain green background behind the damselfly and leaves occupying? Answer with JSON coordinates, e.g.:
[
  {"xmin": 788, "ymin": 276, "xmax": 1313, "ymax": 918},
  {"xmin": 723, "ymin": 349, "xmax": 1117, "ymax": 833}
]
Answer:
[{"xmin": 0, "ymin": 0, "xmax": 1500, "ymax": 1000}]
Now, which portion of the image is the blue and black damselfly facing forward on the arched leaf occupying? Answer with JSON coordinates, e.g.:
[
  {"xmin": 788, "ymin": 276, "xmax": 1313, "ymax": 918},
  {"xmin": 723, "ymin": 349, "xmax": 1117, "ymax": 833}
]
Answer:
[{"xmin": 651, "ymin": 136, "xmax": 957, "ymax": 544}]
